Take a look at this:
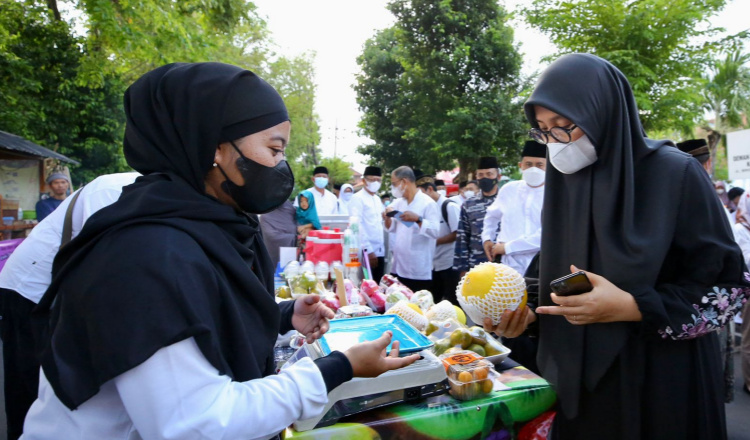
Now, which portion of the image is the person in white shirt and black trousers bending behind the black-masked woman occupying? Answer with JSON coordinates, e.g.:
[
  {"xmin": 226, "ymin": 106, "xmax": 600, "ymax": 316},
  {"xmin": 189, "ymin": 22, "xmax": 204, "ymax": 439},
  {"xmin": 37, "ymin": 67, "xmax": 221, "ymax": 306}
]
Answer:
[{"xmin": 0, "ymin": 173, "xmax": 139, "ymax": 439}]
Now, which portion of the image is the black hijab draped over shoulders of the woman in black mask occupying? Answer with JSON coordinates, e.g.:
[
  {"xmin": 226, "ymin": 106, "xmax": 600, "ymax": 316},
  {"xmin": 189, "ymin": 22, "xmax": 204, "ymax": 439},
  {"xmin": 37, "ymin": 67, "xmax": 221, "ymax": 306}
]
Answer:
[{"xmin": 34, "ymin": 63, "xmax": 288, "ymax": 409}]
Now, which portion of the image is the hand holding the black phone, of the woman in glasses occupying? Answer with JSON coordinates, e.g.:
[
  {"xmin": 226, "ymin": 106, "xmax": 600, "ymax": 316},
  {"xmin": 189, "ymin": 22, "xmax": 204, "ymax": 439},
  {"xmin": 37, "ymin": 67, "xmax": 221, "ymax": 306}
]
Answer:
[{"xmin": 536, "ymin": 265, "xmax": 642, "ymax": 325}]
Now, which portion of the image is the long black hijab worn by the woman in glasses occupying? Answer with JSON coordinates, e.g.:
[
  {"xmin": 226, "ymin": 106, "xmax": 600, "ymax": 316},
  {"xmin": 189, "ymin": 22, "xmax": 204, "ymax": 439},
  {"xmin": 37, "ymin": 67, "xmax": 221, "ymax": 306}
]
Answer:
[{"xmin": 525, "ymin": 54, "xmax": 690, "ymax": 417}]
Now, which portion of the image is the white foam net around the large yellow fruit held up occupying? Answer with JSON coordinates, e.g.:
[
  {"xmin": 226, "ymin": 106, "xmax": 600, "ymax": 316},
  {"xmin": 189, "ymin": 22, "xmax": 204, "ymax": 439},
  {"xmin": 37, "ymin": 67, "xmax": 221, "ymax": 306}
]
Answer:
[{"xmin": 456, "ymin": 262, "xmax": 526, "ymax": 325}]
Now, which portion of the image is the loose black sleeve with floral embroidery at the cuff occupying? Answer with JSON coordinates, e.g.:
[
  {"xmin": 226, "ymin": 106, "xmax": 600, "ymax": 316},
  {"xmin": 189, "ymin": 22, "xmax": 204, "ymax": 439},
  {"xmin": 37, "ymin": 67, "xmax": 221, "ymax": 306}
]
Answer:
[{"xmin": 630, "ymin": 161, "xmax": 750, "ymax": 340}]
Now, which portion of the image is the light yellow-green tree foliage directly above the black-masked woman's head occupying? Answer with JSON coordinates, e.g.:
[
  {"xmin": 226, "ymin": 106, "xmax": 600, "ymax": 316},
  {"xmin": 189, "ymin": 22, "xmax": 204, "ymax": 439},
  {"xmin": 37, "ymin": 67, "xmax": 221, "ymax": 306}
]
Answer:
[{"xmin": 57, "ymin": 0, "xmax": 268, "ymax": 84}]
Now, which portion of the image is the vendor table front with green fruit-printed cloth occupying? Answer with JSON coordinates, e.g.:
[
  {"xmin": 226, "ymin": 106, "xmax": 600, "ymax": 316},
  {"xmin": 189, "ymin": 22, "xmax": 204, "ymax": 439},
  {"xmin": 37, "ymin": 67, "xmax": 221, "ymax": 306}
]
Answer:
[{"xmin": 285, "ymin": 360, "xmax": 556, "ymax": 440}]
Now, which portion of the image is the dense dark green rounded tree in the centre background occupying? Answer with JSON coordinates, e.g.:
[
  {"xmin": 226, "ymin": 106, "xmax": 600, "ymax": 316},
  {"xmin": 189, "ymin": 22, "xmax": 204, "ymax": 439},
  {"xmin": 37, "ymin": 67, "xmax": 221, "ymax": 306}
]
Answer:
[{"xmin": 355, "ymin": 0, "xmax": 524, "ymax": 177}]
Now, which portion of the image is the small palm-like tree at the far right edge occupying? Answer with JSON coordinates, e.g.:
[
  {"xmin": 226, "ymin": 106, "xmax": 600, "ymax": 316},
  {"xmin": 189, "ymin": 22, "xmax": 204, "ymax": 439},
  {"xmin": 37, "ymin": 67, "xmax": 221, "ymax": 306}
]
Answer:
[{"xmin": 702, "ymin": 49, "xmax": 750, "ymax": 177}]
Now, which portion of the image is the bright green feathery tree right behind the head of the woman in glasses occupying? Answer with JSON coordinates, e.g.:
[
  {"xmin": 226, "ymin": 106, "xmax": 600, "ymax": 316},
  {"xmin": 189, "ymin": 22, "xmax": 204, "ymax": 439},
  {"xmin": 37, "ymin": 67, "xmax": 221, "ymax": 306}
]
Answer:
[{"xmin": 524, "ymin": 0, "xmax": 745, "ymax": 133}]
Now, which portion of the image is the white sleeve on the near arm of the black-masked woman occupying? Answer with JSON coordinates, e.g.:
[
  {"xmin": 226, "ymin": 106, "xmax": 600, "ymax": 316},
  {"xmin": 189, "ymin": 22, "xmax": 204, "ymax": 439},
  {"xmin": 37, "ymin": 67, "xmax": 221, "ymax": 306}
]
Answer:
[{"xmin": 114, "ymin": 338, "xmax": 328, "ymax": 439}]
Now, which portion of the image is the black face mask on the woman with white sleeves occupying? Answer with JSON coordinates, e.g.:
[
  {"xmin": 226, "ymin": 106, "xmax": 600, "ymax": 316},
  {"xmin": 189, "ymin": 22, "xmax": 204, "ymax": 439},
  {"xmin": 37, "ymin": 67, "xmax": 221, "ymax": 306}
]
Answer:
[{"xmin": 219, "ymin": 142, "xmax": 294, "ymax": 214}]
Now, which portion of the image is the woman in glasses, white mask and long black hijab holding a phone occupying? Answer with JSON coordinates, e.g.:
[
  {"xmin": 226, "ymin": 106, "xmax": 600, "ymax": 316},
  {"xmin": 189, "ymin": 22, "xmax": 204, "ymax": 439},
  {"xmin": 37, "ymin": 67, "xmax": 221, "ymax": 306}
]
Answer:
[{"xmin": 484, "ymin": 54, "xmax": 748, "ymax": 440}]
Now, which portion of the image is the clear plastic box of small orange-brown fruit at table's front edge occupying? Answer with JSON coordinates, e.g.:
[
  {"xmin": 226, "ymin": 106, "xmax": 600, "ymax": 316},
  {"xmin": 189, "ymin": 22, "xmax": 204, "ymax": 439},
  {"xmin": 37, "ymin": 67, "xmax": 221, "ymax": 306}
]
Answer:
[{"xmin": 440, "ymin": 348, "xmax": 496, "ymax": 400}]
